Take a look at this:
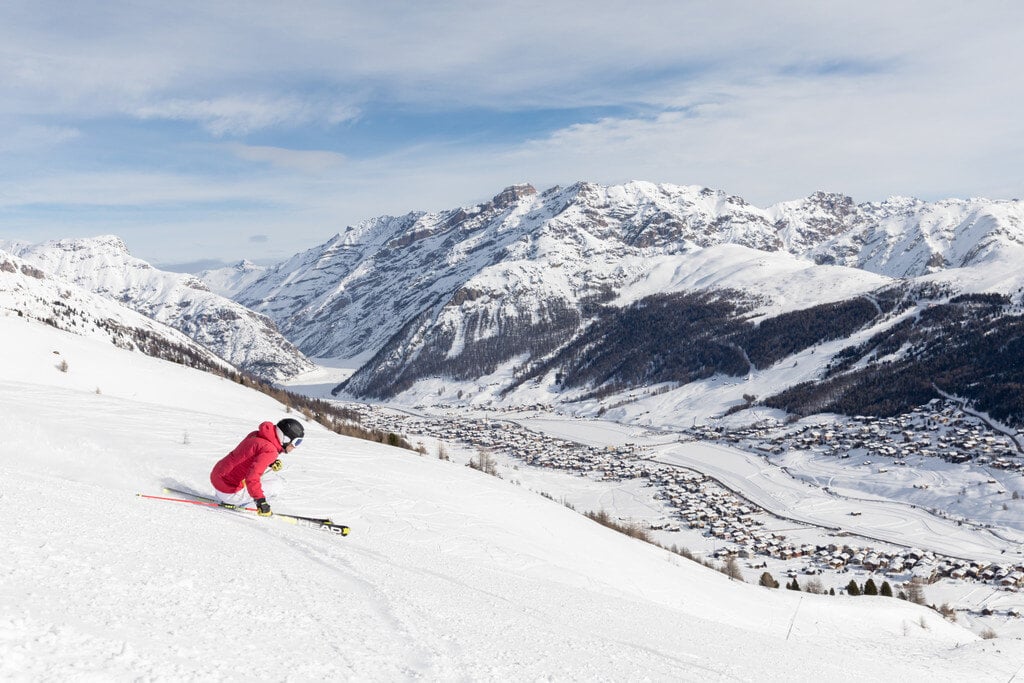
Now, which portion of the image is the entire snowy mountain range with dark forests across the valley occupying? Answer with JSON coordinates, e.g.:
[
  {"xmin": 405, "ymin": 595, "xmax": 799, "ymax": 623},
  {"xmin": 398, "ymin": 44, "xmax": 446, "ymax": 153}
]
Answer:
[{"xmin": 0, "ymin": 182, "xmax": 1024, "ymax": 425}]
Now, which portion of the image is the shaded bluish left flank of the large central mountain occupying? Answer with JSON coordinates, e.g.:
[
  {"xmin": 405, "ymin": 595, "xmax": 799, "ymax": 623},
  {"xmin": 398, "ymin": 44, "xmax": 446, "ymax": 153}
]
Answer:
[{"xmin": 237, "ymin": 187, "xmax": 552, "ymax": 358}]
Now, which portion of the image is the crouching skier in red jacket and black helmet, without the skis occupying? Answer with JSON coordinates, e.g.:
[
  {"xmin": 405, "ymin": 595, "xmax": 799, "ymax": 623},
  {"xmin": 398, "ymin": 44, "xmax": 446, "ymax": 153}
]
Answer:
[{"xmin": 210, "ymin": 418, "xmax": 305, "ymax": 517}]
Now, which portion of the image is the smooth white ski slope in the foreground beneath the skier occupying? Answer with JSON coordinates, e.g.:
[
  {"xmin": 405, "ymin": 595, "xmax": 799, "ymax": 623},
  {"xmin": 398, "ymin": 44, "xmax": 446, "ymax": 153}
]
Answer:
[{"xmin": 0, "ymin": 316, "xmax": 1024, "ymax": 682}]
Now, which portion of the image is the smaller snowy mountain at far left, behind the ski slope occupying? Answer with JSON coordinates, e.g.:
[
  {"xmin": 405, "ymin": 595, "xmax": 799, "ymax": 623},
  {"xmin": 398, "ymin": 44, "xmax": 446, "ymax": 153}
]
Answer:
[{"xmin": 0, "ymin": 236, "xmax": 313, "ymax": 381}]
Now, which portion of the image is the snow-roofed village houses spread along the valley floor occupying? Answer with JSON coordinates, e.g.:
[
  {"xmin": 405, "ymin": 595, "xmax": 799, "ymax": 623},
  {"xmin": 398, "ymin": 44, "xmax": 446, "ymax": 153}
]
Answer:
[{"xmin": 344, "ymin": 404, "xmax": 1024, "ymax": 589}]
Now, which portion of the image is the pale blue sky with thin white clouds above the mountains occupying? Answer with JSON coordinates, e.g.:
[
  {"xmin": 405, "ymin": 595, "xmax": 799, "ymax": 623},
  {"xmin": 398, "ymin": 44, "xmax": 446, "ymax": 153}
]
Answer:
[{"xmin": 0, "ymin": 0, "xmax": 1024, "ymax": 268}]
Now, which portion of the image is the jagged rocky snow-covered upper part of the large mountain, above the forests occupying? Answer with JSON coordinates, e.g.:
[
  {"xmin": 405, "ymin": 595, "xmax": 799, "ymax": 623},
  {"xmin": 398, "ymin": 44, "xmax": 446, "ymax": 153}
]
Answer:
[{"xmin": 238, "ymin": 180, "xmax": 1021, "ymax": 374}]
